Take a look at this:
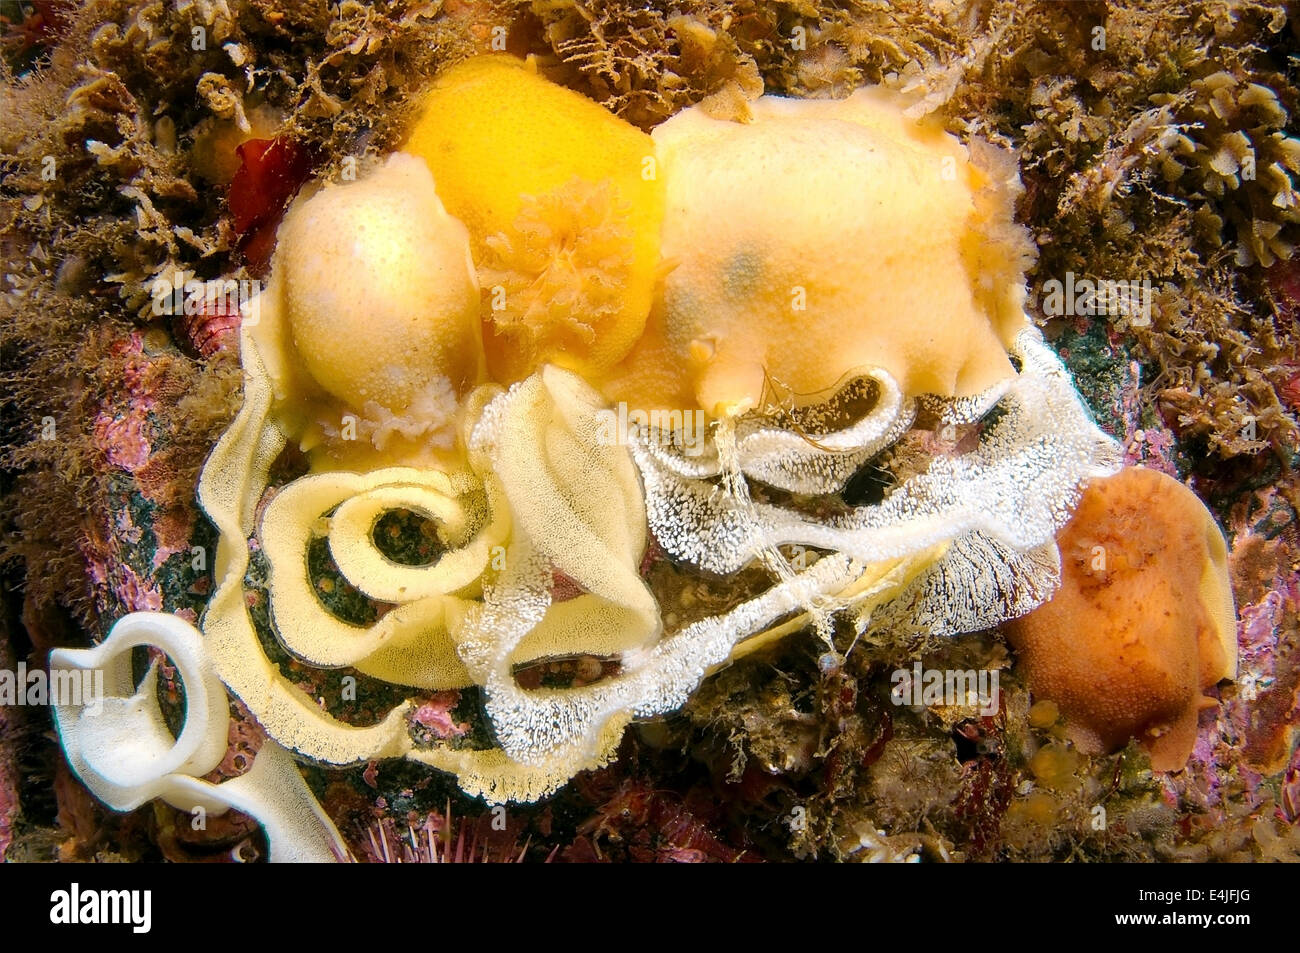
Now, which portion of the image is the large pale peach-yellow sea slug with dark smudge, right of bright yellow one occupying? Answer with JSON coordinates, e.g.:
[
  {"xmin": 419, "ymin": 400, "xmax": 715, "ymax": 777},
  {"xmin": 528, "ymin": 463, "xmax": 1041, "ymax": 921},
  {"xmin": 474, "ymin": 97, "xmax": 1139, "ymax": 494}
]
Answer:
[{"xmin": 606, "ymin": 88, "xmax": 1032, "ymax": 416}]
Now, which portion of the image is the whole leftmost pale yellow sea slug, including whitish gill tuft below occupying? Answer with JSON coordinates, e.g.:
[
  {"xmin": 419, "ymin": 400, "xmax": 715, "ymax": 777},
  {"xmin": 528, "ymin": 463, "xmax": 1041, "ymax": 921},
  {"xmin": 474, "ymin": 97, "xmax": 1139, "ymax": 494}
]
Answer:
[{"xmin": 244, "ymin": 153, "xmax": 485, "ymax": 469}]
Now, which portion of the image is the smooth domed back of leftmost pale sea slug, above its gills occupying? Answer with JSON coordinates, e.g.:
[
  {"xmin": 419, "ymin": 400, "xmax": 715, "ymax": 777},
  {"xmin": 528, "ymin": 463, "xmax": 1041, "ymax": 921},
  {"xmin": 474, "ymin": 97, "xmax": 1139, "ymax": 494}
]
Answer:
[{"xmin": 273, "ymin": 153, "xmax": 484, "ymax": 413}]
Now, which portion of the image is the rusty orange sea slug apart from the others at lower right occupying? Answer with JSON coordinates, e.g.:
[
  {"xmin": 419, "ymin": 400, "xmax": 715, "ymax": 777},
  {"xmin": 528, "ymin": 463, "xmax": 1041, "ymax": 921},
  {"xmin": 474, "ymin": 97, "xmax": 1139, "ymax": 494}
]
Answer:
[{"xmin": 1006, "ymin": 468, "xmax": 1236, "ymax": 771}]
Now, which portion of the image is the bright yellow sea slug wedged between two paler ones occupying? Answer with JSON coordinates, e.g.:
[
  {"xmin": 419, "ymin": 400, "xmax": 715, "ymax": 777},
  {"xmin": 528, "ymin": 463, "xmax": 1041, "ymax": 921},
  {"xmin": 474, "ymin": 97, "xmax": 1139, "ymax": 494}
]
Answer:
[{"xmin": 402, "ymin": 56, "xmax": 663, "ymax": 382}]
